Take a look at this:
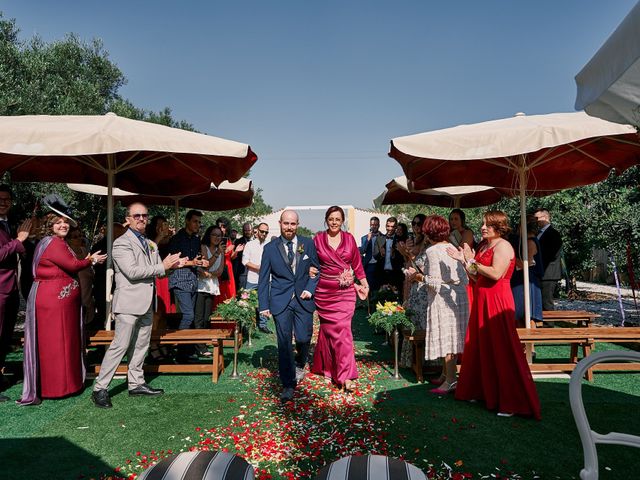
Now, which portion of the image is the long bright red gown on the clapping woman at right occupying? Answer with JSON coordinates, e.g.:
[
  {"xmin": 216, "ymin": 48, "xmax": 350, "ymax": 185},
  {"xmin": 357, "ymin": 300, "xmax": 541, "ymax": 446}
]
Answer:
[{"xmin": 456, "ymin": 249, "xmax": 540, "ymax": 419}]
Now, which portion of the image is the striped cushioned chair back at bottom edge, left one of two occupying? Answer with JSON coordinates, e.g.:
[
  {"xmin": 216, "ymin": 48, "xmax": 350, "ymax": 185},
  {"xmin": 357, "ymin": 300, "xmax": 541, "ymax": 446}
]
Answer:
[{"xmin": 139, "ymin": 451, "xmax": 255, "ymax": 480}]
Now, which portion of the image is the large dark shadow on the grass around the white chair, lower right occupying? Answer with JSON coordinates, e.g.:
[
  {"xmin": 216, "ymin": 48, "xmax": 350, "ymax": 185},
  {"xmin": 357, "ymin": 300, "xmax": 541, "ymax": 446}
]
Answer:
[{"xmin": 373, "ymin": 377, "xmax": 640, "ymax": 479}]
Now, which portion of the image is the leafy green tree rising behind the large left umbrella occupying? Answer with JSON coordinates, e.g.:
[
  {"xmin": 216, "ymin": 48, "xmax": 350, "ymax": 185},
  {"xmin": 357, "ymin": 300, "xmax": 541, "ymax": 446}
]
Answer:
[{"xmin": 0, "ymin": 12, "xmax": 271, "ymax": 233}]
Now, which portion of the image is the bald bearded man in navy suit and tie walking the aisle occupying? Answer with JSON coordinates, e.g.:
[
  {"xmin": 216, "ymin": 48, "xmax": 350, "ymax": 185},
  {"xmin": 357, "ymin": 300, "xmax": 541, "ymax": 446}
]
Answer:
[{"xmin": 258, "ymin": 210, "xmax": 320, "ymax": 402}]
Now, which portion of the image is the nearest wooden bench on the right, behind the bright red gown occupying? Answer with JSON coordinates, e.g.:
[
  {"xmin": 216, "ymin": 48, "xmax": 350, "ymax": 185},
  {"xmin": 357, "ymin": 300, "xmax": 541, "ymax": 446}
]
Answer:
[{"xmin": 517, "ymin": 327, "xmax": 640, "ymax": 381}]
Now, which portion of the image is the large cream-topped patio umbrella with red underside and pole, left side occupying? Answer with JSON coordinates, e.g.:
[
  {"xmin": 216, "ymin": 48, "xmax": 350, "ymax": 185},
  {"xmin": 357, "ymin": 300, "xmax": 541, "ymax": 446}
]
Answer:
[{"xmin": 0, "ymin": 113, "xmax": 258, "ymax": 323}]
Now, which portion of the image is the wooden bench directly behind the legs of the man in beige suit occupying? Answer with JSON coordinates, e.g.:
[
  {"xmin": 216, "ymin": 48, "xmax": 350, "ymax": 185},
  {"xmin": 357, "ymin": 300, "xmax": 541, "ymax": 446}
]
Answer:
[{"xmin": 88, "ymin": 326, "xmax": 234, "ymax": 383}]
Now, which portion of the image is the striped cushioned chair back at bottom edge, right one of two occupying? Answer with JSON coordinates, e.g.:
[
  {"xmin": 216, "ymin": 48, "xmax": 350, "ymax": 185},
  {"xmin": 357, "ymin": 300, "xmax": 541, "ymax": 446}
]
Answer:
[{"xmin": 315, "ymin": 455, "xmax": 427, "ymax": 480}]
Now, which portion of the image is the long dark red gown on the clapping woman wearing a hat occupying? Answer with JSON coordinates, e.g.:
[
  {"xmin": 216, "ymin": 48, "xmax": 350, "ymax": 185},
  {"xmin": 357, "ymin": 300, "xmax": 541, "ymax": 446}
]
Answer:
[{"xmin": 35, "ymin": 237, "xmax": 91, "ymax": 398}]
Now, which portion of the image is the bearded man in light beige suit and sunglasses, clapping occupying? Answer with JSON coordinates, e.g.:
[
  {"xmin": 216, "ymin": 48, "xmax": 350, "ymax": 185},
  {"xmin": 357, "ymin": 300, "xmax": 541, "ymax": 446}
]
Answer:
[{"xmin": 91, "ymin": 203, "xmax": 186, "ymax": 408}]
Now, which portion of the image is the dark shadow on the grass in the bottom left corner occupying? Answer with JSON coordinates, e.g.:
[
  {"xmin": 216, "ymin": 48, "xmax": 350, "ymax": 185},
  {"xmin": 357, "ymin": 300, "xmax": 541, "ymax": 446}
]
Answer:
[{"xmin": 0, "ymin": 437, "xmax": 113, "ymax": 480}]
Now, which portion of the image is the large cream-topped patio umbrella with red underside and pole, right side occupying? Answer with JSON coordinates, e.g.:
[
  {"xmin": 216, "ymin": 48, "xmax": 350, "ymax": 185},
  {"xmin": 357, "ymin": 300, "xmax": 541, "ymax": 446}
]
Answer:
[{"xmin": 389, "ymin": 112, "xmax": 640, "ymax": 342}]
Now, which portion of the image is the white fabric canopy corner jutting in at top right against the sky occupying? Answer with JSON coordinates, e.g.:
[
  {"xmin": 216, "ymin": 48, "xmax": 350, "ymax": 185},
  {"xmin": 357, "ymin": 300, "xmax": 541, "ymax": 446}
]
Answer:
[{"xmin": 575, "ymin": 2, "xmax": 640, "ymax": 125}]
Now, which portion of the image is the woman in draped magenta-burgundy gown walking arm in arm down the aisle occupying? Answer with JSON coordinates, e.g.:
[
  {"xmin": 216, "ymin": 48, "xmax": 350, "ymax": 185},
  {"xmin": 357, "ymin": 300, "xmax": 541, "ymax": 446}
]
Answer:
[{"xmin": 311, "ymin": 206, "xmax": 369, "ymax": 391}]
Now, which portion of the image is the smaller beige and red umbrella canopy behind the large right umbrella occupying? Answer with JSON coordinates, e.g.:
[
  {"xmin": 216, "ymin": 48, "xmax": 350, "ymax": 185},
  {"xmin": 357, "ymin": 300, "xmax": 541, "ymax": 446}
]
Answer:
[{"xmin": 374, "ymin": 176, "xmax": 504, "ymax": 208}]
